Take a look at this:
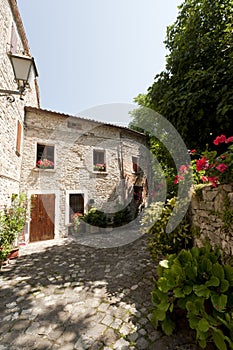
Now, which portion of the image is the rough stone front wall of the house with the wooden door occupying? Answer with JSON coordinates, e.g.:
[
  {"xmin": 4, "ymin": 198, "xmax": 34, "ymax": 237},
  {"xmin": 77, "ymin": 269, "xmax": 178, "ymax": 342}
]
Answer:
[{"xmin": 20, "ymin": 107, "xmax": 148, "ymax": 240}]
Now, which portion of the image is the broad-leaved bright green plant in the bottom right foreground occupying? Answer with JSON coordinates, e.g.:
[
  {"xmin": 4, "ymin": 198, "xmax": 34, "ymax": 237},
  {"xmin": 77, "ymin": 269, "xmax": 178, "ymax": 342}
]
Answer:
[{"xmin": 152, "ymin": 244, "xmax": 233, "ymax": 350}]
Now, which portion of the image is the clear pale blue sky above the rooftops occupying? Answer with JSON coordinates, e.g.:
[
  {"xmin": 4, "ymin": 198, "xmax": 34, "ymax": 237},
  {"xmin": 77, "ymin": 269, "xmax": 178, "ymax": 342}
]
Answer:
[{"xmin": 18, "ymin": 0, "xmax": 182, "ymax": 122}]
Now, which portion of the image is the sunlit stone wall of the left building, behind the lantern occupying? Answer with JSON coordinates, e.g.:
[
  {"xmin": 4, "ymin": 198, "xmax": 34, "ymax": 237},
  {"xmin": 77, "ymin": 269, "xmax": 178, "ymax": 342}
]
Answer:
[{"xmin": 0, "ymin": 0, "xmax": 39, "ymax": 208}]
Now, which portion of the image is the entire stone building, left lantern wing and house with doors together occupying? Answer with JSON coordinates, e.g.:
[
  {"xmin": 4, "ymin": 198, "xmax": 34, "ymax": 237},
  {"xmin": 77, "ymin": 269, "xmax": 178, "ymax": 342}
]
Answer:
[{"xmin": 0, "ymin": 0, "xmax": 148, "ymax": 242}]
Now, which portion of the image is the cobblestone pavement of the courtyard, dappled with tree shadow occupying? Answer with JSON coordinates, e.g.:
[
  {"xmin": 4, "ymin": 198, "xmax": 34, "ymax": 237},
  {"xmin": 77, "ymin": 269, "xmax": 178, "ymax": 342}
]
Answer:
[{"xmin": 0, "ymin": 237, "xmax": 199, "ymax": 350}]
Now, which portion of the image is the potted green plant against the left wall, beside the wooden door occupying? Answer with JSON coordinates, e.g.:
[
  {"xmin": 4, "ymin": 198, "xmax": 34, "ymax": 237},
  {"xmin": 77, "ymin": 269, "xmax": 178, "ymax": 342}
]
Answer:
[{"xmin": 0, "ymin": 194, "xmax": 27, "ymax": 261}]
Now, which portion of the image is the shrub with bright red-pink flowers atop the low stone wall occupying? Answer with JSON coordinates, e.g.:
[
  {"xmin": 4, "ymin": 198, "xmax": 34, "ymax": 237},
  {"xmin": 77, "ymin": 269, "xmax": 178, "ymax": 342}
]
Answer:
[{"xmin": 174, "ymin": 135, "xmax": 233, "ymax": 187}]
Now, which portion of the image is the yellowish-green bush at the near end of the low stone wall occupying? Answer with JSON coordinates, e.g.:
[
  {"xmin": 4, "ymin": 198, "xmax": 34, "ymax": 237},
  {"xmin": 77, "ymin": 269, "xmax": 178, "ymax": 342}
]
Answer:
[{"xmin": 142, "ymin": 197, "xmax": 193, "ymax": 260}]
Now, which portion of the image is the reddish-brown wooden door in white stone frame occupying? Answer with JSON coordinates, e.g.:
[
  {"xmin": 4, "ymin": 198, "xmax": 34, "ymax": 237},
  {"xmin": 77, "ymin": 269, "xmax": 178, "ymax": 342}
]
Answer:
[{"xmin": 30, "ymin": 194, "xmax": 55, "ymax": 242}]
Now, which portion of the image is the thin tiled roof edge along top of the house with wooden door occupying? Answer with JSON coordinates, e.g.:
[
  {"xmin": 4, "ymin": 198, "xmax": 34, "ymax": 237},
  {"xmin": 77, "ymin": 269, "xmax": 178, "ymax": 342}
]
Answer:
[{"xmin": 25, "ymin": 106, "xmax": 146, "ymax": 138}]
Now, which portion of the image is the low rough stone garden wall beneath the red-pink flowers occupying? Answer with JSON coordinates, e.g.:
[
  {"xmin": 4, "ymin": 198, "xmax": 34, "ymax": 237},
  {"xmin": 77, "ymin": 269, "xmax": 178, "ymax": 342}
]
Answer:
[{"xmin": 191, "ymin": 184, "xmax": 233, "ymax": 255}]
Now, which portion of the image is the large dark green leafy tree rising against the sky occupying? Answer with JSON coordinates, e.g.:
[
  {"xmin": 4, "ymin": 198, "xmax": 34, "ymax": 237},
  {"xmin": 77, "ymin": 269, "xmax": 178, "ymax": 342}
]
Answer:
[{"xmin": 131, "ymin": 0, "xmax": 233, "ymax": 149}]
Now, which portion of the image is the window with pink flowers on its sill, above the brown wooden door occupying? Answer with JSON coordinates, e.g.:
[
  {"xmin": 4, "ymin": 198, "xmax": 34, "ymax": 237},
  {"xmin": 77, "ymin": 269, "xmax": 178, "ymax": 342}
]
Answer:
[{"xmin": 36, "ymin": 143, "xmax": 54, "ymax": 169}]
